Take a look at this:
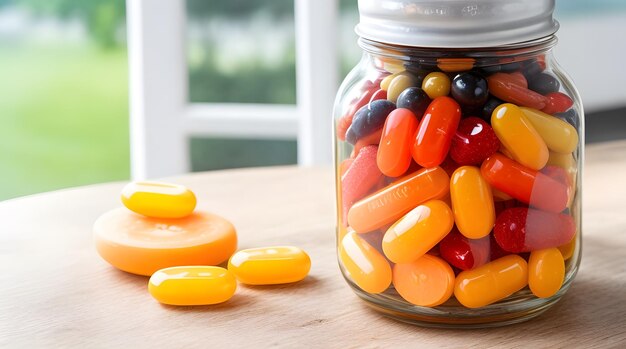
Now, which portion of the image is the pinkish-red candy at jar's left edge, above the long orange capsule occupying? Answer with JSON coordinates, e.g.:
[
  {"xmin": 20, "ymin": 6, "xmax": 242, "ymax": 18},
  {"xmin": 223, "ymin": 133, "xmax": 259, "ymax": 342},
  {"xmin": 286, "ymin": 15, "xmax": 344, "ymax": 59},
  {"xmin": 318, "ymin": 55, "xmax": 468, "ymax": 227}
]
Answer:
[{"xmin": 341, "ymin": 145, "xmax": 383, "ymax": 221}]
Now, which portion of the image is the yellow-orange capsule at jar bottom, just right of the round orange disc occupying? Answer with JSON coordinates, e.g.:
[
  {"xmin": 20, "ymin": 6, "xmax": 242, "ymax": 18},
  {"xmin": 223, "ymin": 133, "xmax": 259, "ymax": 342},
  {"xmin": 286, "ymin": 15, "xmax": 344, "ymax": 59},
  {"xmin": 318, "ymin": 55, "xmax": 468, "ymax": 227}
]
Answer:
[{"xmin": 454, "ymin": 254, "xmax": 528, "ymax": 308}]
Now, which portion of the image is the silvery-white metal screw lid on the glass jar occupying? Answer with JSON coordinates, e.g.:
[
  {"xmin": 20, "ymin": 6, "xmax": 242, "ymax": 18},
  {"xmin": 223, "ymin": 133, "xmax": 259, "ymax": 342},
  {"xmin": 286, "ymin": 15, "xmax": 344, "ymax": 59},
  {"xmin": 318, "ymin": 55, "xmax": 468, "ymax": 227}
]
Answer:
[{"xmin": 355, "ymin": 0, "xmax": 559, "ymax": 48}]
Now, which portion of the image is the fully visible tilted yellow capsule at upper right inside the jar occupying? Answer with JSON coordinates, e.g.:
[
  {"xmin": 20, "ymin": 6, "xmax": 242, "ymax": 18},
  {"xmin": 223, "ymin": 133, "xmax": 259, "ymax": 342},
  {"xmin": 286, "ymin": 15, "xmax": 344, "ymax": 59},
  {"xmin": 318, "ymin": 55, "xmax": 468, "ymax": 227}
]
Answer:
[{"xmin": 491, "ymin": 103, "xmax": 549, "ymax": 170}]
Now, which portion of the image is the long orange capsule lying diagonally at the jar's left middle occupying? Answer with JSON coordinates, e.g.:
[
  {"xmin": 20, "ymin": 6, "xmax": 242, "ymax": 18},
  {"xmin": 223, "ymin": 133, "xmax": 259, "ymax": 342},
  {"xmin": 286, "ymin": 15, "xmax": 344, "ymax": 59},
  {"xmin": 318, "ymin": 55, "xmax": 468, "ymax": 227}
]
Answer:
[{"xmin": 348, "ymin": 167, "xmax": 450, "ymax": 233}]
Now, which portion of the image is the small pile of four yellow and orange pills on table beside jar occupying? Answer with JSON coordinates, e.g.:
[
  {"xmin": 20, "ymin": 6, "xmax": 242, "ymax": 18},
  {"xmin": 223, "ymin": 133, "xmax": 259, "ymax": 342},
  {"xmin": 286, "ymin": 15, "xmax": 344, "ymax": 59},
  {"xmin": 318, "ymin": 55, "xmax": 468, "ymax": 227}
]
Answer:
[{"xmin": 94, "ymin": 182, "xmax": 311, "ymax": 305}]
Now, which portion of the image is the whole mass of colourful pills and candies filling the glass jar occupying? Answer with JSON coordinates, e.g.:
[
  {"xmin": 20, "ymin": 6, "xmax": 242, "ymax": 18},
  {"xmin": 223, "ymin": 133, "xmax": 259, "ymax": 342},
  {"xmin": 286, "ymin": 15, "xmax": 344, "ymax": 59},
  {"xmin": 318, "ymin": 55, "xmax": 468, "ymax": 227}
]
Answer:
[{"xmin": 336, "ymin": 57, "xmax": 579, "ymax": 308}]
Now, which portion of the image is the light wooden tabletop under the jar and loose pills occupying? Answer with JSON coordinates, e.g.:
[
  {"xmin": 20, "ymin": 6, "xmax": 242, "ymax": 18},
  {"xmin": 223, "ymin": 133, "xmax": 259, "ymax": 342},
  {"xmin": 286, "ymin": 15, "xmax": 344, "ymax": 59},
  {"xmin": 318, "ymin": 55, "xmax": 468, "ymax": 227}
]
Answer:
[{"xmin": 0, "ymin": 142, "xmax": 626, "ymax": 348}]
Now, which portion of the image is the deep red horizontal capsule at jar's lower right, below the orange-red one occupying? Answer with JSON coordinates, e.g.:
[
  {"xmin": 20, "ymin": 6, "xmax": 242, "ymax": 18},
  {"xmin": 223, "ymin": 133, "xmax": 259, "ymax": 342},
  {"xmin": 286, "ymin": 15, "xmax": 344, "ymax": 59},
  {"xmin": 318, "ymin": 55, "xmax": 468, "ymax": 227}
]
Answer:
[{"xmin": 493, "ymin": 207, "xmax": 576, "ymax": 253}]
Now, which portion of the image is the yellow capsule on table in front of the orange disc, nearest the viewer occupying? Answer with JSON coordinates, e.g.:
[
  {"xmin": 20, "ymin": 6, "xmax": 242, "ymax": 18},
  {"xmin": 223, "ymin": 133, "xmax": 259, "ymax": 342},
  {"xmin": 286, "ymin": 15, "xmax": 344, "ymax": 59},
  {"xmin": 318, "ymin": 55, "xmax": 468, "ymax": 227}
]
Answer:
[{"xmin": 148, "ymin": 266, "xmax": 237, "ymax": 305}]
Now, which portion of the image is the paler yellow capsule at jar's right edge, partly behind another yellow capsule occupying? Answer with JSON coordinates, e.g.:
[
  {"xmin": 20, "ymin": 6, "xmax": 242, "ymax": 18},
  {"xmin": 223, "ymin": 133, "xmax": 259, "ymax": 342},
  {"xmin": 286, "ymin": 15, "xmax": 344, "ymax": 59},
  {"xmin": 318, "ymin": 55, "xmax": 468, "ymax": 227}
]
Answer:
[{"xmin": 520, "ymin": 107, "xmax": 578, "ymax": 154}]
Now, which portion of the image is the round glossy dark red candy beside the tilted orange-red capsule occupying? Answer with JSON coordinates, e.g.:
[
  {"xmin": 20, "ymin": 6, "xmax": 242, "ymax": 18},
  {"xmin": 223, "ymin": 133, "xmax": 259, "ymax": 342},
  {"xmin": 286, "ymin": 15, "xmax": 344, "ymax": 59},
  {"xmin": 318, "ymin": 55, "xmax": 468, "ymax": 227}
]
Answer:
[{"xmin": 450, "ymin": 116, "xmax": 500, "ymax": 166}]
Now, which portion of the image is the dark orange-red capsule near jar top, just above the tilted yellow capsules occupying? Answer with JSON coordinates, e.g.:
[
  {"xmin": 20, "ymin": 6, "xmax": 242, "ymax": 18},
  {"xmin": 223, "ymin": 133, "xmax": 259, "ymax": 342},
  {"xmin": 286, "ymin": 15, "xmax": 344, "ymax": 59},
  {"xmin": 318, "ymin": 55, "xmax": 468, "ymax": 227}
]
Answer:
[{"xmin": 487, "ymin": 73, "xmax": 548, "ymax": 110}]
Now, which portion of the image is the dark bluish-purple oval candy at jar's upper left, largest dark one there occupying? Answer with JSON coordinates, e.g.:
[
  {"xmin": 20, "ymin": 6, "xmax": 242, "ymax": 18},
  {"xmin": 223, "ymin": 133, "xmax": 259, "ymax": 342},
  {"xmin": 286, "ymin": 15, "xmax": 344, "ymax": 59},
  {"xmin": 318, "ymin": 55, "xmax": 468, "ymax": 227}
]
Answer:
[{"xmin": 346, "ymin": 99, "xmax": 396, "ymax": 144}]
